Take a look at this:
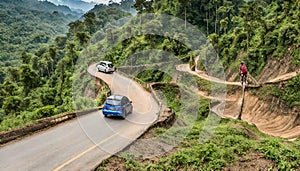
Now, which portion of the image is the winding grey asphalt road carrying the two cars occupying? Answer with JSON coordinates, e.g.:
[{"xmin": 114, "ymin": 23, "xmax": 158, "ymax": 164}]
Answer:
[{"xmin": 0, "ymin": 65, "xmax": 159, "ymax": 171}]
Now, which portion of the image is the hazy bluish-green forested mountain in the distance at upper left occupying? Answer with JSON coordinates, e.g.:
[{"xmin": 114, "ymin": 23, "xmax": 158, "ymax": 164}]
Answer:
[{"xmin": 0, "ymin": 0, "xmax": 80, "ymax": 76}]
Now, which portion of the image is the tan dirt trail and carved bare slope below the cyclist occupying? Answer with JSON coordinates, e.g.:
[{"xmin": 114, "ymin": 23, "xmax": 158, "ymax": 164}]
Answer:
[{"xmin": 176, "ymin": 58, "xmax": 300, "ymax": 139}]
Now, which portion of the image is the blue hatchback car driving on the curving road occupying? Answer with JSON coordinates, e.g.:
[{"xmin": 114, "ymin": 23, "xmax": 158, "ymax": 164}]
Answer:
[{"xmin": 102, "ymin": 95, "xmax": 133, "ymax": 118}]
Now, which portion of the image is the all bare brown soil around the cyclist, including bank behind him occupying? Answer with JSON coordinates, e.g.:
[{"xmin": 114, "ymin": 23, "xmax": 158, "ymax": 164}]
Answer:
[{"xmin": 177, "ymin": 58, "xmax": 300, "ymax": 139}]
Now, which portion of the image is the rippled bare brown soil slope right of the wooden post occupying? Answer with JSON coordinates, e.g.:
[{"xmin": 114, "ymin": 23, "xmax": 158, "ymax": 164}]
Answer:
[{"xmin": 242, "ymin": 92, "xmax": 300, "ymax": 139}]
